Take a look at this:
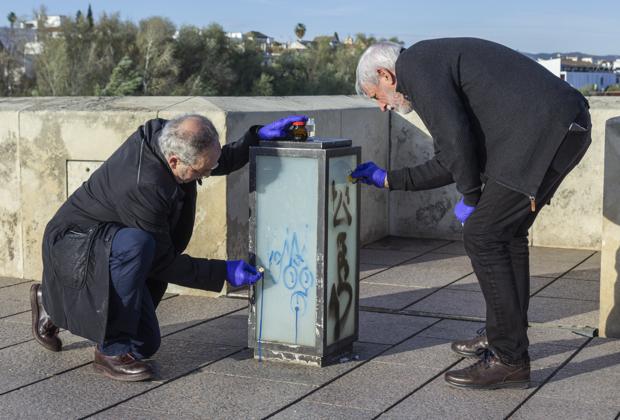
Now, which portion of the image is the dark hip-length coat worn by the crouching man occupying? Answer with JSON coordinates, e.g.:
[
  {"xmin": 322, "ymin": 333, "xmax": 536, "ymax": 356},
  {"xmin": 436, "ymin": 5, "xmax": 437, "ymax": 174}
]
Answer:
[{"xmin": 43, "ymin": 119, "xmax": 258, "ymax": 342}]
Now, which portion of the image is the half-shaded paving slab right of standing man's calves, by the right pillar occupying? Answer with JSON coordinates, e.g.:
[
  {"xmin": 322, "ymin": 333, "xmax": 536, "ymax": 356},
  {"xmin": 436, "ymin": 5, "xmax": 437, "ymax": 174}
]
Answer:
[{"xmin": 528, "ymin": 296, "xmax": 599, "ymax": 327}]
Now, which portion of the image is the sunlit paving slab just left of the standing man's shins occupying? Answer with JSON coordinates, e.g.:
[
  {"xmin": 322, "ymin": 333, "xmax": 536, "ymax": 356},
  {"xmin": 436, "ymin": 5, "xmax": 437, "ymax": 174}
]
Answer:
[{"xmin": 364, "ymin": 253, "xmax": 473, "ymax": 287}]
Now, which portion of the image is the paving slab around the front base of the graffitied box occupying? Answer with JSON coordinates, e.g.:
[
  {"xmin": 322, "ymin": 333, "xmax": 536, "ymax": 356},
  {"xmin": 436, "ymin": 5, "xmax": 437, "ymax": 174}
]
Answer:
[{"xmin": 204, "ymin": 343, "xmax": 389, "ymax": 386}]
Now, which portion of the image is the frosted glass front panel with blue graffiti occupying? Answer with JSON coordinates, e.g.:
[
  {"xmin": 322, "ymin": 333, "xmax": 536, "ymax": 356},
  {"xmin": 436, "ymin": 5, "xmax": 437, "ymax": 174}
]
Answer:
[{"xmin": 256, "ymin": 156, "xmax": 318, "ymax": 347}]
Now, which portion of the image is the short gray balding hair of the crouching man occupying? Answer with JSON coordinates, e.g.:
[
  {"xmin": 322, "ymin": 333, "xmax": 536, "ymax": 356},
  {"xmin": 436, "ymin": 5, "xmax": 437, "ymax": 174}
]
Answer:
[{"xmin": 159, "ymin": 114, "xmax": 220, "ymax": 165}]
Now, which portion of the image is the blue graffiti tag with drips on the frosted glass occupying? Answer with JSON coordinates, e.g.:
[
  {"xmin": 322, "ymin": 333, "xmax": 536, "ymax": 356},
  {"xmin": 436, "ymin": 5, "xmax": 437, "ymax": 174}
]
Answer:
[{"xmin": 269, "ymin": 229, "xmax": 314, "ymax": 344}]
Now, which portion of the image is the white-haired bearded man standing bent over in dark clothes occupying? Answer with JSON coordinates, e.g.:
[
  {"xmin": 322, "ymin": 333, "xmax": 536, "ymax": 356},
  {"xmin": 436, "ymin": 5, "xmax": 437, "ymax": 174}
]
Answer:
[{"xmin": 352, "ymin": 38, "xmax": 591, "ymax": 389}]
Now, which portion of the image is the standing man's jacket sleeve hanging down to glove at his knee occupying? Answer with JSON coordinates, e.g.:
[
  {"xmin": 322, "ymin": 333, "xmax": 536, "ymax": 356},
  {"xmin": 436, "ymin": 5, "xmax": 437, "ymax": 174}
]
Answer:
[{"xmin": 398, "ymin": 46, "xmax": 481, "ymax": 205}]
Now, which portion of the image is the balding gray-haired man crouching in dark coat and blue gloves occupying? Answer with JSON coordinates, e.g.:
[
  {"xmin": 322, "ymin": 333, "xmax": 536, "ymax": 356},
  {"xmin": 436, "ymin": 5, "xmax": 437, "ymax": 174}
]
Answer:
[{"xmin": 30, "ymin": 114, "xmax": 307, "ymax": 381}]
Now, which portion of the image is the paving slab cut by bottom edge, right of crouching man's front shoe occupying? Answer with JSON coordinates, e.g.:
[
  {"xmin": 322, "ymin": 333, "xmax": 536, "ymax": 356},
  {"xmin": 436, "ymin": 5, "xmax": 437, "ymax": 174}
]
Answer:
[{"xmin": 127, "ymin": 371, "xmax": 314, "ymax": 419}]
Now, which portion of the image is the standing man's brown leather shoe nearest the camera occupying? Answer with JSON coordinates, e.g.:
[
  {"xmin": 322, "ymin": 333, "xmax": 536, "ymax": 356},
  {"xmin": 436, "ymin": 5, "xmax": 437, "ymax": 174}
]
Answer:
[{"xmin": 445, "ymin": 350, "xmax": 530, "ymax": 389}]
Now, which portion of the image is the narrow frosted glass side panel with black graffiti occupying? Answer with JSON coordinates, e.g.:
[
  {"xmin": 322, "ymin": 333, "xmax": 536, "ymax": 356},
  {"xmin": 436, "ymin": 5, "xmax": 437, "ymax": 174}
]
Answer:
[{"xmin": 326, "ymin": 155, "xmax": 358, "ymax": 345}]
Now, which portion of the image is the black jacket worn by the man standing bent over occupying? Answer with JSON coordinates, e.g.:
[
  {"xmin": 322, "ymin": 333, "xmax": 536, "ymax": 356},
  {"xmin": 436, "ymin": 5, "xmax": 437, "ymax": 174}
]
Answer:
[{"xmin": 388, "ymin": 38, "xmax": 587, "ymax": 205}]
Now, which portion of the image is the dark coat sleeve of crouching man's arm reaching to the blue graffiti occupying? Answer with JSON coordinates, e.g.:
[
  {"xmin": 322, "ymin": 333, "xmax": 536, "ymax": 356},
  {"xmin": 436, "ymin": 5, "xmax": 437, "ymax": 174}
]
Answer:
[{"xmin": 117, "ymin": 183, "xmax": 226, "ymax": 292}]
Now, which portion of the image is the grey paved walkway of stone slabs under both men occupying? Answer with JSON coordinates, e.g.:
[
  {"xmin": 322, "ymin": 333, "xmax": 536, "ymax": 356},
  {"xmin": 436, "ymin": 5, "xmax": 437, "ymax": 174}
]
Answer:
[{"xmin": 0, "ymin": 238, "xmax": 620, "ymax": 420}]
